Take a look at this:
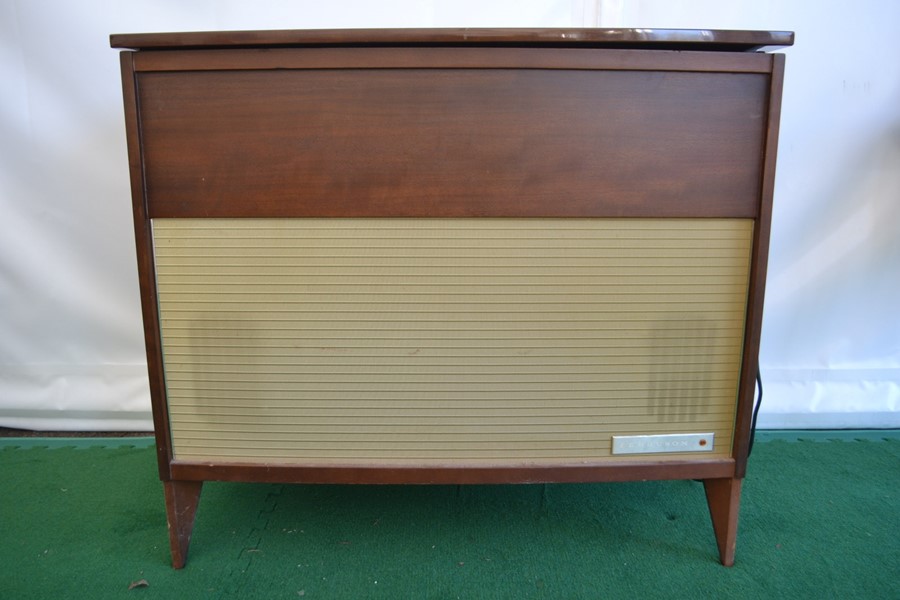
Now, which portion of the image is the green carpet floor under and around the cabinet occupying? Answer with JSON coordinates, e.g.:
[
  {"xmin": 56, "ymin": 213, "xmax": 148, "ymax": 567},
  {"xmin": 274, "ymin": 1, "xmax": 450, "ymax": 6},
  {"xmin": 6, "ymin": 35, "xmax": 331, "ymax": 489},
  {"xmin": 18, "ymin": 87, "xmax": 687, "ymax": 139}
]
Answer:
[{"xmin": 0, "ymin": 432, "xmax": 900, "ymax": 600}]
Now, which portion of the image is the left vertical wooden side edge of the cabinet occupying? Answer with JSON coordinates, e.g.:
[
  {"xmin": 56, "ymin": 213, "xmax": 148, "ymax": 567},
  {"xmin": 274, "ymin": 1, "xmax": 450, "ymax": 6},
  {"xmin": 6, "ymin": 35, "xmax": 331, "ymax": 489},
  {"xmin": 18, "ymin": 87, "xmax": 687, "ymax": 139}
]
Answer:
[{"xmin": 119, "ymin": 52, "xmax": 172, "ymax": 481}]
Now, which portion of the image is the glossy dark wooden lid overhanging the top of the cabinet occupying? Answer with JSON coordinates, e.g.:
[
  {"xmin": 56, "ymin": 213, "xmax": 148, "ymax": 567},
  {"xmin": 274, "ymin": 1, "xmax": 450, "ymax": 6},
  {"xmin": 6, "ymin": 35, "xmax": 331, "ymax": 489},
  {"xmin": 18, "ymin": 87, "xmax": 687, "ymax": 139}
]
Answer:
[{"xmin": 110, "ymin": 28, "xmax": 794, "ymax": 52}]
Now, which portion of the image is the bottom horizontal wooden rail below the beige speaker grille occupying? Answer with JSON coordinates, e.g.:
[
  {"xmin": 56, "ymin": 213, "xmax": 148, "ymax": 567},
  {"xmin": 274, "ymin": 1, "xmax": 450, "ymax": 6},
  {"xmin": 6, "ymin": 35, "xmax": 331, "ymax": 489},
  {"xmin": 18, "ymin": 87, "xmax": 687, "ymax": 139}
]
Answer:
[{"xmin": 172, "ymin": 458, "xmax": 734, "ymax": 484}]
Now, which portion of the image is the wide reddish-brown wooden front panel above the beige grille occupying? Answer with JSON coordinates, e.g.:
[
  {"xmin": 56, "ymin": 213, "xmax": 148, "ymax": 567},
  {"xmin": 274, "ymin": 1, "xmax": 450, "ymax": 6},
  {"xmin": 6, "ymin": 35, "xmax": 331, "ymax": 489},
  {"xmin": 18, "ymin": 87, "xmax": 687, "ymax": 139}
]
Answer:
[{"xmin": 137, "ymin": 68, "xmax": 769, "ymax": 218}]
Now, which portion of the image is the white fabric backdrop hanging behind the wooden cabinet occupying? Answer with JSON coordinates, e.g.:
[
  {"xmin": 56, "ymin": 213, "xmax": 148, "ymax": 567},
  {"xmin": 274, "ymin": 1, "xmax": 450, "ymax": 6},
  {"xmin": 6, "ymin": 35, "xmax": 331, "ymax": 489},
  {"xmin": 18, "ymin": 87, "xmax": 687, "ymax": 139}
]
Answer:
[{"xmin": 0, "ymin": 0, "xmax": 900, "ymax": 430}]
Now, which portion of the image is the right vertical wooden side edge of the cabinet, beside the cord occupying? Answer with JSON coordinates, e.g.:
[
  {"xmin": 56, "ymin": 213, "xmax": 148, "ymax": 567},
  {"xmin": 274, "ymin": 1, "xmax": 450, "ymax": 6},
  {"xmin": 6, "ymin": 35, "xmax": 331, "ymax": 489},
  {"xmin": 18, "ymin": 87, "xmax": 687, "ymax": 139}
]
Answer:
[{"xmin": 732, "ymin": 54, "xmax": 784, "ymax": 478}]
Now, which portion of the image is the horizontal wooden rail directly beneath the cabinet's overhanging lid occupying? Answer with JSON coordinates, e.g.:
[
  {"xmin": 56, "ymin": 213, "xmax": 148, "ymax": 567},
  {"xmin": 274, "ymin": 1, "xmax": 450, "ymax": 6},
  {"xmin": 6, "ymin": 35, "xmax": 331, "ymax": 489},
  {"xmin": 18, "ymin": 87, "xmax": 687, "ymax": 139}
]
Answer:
[{"xmin": 134, "ymin": 47, "xmax": 771, "ymax": 73}]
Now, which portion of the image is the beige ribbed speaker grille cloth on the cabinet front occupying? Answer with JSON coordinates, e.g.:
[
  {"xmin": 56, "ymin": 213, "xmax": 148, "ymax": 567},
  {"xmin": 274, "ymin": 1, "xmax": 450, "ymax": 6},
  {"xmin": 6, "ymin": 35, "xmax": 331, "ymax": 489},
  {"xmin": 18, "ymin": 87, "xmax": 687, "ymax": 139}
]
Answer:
[{"xmin": 153, "ymin": 219, "xmax": 752, "ymax": 465}]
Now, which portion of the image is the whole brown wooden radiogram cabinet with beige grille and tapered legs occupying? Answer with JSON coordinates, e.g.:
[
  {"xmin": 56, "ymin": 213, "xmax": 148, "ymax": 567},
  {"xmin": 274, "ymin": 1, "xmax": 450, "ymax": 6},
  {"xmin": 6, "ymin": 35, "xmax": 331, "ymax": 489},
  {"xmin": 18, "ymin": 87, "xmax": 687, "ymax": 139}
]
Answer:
[{"xmin": 112, "ymin": 29, "xmax": 793, "ymax": 567}]
